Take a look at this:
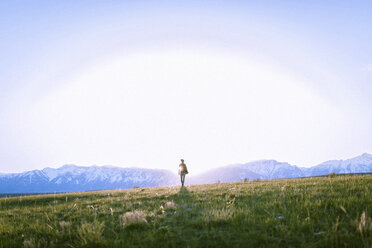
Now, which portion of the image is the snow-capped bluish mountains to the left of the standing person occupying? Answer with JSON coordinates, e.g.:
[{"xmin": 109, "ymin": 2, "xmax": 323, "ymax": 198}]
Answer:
[{"xmin": 0, "ymin": 165, "xmax": 178, "ymax": 193}]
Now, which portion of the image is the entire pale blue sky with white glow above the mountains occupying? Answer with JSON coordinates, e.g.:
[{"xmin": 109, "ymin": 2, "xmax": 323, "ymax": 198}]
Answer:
[{"xmin": 0, "ymin": 0, "xmax": 372, "ymax": 173}]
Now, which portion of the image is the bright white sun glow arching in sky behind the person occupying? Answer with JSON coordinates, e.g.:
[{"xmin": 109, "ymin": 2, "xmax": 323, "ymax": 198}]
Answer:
[{"xmin": 7, "ymin": 50, "xmax": 346, "ymax": 173}]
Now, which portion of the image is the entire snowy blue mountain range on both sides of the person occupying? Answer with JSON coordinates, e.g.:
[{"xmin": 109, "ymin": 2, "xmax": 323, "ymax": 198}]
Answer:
[{"xmin": 0, "ymin": 153, "xmax": 372, "ymax": 194}]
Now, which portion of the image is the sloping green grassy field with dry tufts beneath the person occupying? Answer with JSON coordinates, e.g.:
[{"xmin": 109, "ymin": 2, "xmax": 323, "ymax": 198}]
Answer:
[{"xmin": 0, "ymin": 175, "xmax": 372, "ymax": 247}]
